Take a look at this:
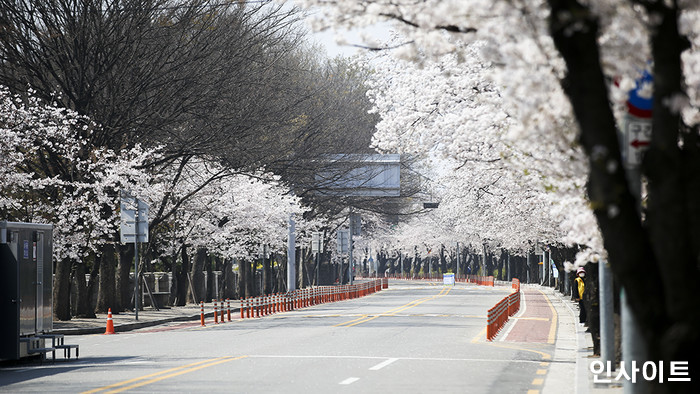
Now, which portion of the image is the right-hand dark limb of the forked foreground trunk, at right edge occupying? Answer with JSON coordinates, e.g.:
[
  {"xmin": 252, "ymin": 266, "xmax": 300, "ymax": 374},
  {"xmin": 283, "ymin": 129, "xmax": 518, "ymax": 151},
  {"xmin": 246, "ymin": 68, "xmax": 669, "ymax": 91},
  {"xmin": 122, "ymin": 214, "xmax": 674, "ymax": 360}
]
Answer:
[{"xmin": 640, "ymin": 2, "xmax": 700, "ymax": 393}]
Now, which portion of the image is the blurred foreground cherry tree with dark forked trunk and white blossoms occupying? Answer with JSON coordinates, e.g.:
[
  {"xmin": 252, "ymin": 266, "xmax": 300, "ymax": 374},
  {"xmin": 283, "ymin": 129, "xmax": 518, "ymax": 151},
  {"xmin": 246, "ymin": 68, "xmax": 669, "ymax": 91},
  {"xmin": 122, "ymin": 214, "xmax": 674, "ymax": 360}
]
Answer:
[{"xmin": 296, "ymin": 0, "xmax": 700, "ymax": 392}]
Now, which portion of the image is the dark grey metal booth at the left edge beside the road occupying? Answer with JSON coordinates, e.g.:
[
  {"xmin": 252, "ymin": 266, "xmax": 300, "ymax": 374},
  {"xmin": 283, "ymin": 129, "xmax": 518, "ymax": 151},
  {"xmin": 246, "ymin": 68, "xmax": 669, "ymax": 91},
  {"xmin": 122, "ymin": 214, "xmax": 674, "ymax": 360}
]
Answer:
[{"xmin": 0, "ymin": 221, "xmax": 55, "ymax": 360}]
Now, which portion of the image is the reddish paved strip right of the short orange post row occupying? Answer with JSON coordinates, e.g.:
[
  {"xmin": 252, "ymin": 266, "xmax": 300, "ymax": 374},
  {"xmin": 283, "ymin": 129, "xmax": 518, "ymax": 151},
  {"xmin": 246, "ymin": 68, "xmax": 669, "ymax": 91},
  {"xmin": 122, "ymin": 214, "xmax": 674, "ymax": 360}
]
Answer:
[{"xmin": 504, "ymin": 289, "xmax": 557, "ymax": 343}]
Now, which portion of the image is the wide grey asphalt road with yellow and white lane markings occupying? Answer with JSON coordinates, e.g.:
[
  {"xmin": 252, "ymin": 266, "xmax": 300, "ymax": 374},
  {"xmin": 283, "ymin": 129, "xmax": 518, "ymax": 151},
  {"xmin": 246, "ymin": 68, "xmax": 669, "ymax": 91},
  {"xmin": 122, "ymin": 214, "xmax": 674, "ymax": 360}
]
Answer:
[{"xmin": 0, "ymin": 281, "xmax": 553, "ymax": 393}]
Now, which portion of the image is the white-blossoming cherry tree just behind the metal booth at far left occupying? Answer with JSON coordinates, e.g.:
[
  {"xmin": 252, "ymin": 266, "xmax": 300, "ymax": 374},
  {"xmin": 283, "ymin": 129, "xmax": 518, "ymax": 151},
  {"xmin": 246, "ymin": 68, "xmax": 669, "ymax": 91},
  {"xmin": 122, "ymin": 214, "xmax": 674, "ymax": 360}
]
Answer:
[{"xmin": 0, "ymin": 87, "xmax": 157, "ymax": 319}]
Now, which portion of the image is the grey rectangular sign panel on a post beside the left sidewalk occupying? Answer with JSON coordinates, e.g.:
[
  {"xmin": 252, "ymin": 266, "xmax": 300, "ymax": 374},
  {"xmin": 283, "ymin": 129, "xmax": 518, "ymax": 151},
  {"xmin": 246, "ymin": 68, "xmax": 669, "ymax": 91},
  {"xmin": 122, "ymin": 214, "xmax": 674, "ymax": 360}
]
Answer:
[{"xmin": 119, "ymin": 190, "xmax": 148, "ymax": 320}]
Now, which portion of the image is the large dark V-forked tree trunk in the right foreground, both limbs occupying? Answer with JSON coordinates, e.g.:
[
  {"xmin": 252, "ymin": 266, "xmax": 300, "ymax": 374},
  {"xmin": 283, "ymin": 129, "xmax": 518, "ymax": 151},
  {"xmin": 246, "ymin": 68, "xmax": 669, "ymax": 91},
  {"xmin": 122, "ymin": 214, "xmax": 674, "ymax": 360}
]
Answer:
[{"xmin": 549, "ymin": 0, "xmax": 700, "ymax": 393}]
